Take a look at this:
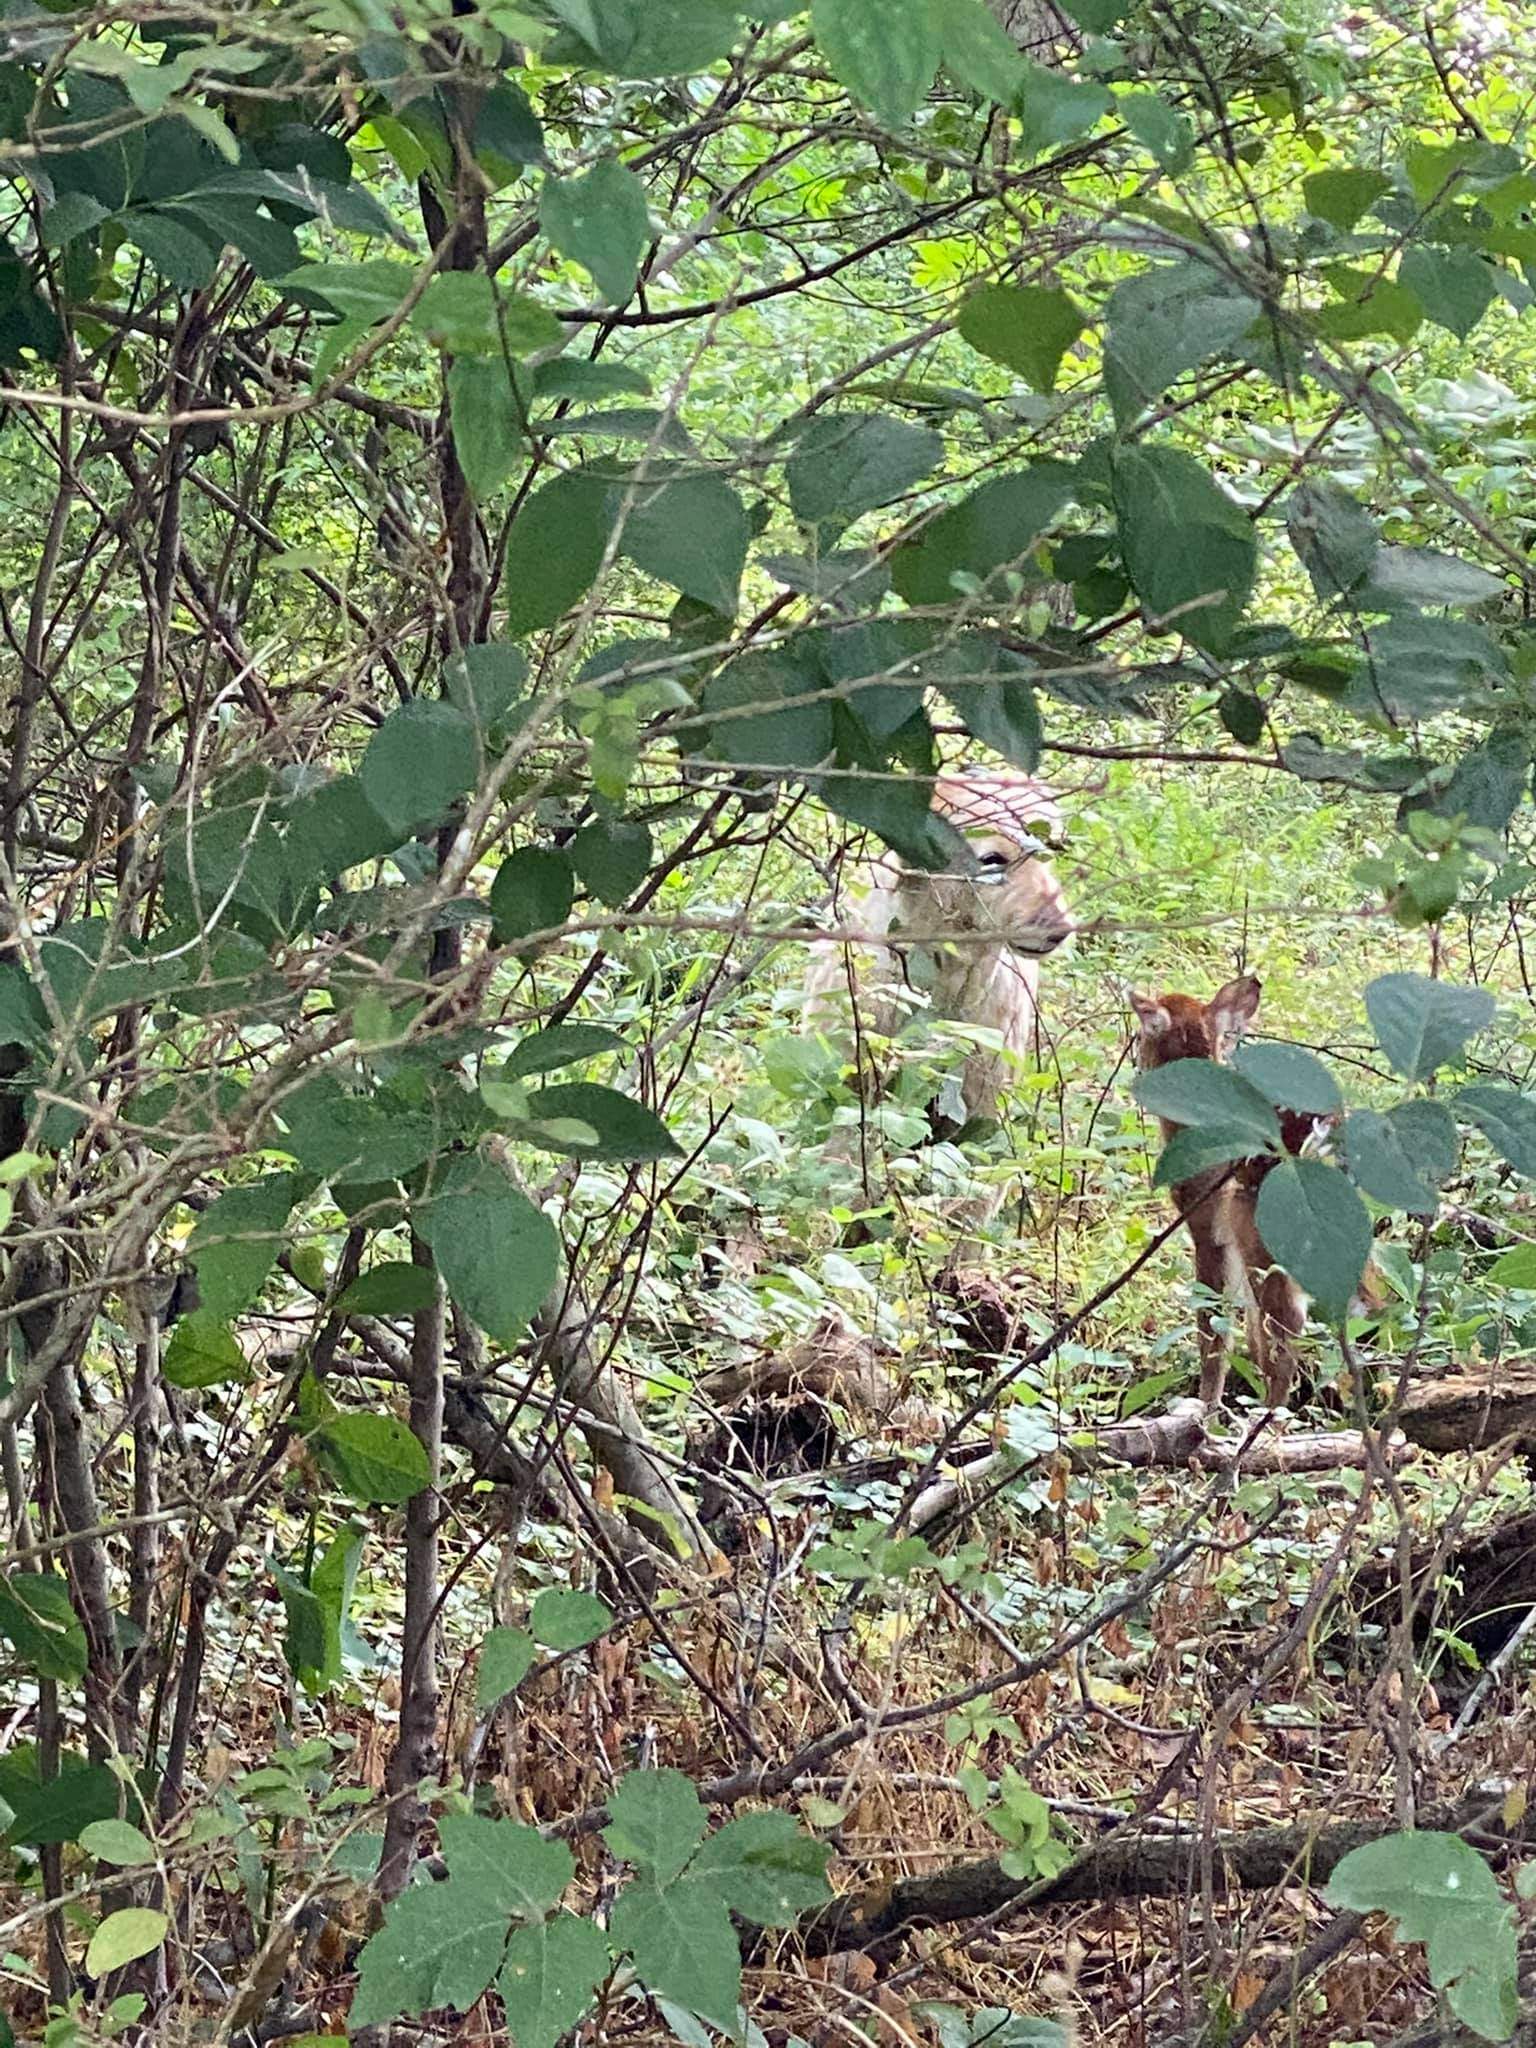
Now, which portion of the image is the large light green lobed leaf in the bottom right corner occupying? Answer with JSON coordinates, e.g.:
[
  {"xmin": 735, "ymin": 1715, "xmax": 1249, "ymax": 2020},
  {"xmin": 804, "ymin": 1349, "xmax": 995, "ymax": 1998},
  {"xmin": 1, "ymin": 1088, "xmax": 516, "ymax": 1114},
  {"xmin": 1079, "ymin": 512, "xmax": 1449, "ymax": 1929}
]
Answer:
[{"xmin": 1325, "ymin": 1829, "xmax": 1518, "ymax": 2040}]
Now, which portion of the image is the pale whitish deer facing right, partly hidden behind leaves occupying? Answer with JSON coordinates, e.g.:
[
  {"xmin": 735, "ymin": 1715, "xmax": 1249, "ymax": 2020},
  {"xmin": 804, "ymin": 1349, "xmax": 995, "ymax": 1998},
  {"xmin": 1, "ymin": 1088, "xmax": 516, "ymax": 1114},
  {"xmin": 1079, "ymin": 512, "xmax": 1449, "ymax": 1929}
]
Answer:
[{"xmin": 803, "ymin": 770, "xmax": 1075, "ymax": 1120}]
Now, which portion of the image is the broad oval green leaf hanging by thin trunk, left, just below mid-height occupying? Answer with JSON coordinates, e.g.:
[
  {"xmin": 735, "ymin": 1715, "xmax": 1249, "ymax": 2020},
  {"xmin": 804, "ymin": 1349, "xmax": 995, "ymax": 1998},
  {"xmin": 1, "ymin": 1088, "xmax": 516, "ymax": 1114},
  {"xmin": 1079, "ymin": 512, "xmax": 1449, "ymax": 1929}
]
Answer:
[{"xmin": 414, "ymin": 1157, "xmax": 559, "ymax": 1346}]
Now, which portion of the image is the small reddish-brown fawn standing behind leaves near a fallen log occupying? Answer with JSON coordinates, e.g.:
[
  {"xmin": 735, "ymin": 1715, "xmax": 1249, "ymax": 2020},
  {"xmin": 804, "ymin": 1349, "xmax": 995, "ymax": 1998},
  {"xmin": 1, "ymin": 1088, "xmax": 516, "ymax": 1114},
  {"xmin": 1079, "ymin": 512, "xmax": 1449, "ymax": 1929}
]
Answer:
[{"xmin": 1130, "ymin": 975, "xmax": 1331, "ymax": 1407}]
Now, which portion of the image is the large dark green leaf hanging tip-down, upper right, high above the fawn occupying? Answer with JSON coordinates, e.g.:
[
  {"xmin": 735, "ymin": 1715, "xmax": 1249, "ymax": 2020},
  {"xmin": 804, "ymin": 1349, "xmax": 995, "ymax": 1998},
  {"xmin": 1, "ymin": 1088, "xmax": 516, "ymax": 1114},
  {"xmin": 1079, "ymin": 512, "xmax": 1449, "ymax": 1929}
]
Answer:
[{"xmin": 1112, "ymin": 446, "xmax": 1257, "ymax": 653}]
